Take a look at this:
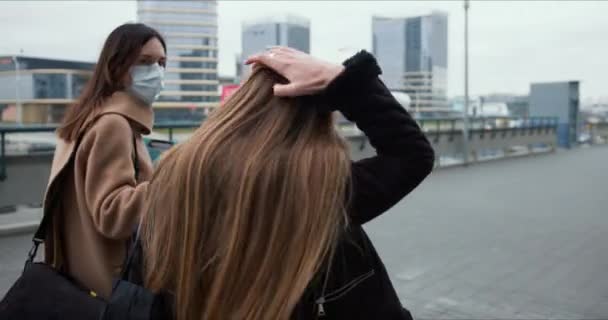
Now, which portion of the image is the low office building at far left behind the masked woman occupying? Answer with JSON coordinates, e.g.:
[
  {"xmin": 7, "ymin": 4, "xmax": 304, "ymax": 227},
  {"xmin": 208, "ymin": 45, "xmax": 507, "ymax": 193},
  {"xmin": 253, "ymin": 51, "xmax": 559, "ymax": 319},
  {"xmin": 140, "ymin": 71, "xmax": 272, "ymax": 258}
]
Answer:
[{"xmin": 0, "ymin": 56, "xmax": 94, "ymax": 123}]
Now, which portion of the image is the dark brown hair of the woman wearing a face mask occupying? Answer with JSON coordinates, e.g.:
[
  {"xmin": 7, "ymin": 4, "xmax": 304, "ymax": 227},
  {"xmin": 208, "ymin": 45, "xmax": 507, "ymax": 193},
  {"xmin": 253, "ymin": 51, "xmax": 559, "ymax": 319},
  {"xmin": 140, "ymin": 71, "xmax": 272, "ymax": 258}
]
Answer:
[{"xmin": 57, "ymin": 23, "xmax": 167, "ymax": 141}]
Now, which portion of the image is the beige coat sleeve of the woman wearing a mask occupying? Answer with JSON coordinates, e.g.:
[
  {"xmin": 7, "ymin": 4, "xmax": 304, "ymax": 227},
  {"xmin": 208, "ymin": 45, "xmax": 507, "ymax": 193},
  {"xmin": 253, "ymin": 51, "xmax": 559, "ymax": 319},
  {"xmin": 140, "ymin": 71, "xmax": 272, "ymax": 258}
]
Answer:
[{"xmin": 80, "ymin": 114, "xmax": 148, "ymax": 239}]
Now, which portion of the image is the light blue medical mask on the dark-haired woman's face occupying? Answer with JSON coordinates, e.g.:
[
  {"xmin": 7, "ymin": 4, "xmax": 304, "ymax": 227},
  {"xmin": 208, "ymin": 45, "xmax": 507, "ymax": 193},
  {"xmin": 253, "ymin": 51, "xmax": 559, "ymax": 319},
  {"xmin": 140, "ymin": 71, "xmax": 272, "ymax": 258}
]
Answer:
[{"xmin": 127, "ymin": 63, "xmax": 165, "ymax": 105}]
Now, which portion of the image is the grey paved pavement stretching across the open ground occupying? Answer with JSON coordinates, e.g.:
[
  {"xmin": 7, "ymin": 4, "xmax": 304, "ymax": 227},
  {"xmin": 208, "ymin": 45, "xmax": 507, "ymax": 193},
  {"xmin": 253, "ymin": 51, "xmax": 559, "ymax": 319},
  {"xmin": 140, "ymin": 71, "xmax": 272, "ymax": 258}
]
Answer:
[{"xmin": 0, "ymin": 146, "xmax": 608, "ymax": 319}]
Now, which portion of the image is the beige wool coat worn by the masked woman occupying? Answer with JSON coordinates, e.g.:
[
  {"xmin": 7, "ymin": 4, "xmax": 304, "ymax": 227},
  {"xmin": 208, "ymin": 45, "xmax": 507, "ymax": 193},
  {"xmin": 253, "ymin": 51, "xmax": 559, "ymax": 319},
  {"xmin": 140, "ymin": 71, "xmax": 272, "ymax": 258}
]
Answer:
[{"xmin": 43, "ymin": 92, "xmax": 154, "ymax": 297}]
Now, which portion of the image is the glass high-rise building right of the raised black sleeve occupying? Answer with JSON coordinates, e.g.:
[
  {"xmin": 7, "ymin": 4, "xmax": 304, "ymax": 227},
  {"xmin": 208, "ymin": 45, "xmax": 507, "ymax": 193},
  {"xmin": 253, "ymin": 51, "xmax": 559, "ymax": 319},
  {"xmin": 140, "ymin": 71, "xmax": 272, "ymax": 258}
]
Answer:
[{"xmin": 372, "ymin": 12, "xmax": 448, "ymax": 111}]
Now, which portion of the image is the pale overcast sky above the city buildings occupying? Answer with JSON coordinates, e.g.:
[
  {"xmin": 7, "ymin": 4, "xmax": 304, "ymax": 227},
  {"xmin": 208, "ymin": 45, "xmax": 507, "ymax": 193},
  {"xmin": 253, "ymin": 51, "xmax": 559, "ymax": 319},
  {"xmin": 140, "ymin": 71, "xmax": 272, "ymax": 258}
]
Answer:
[{"xmin": 0, "ymin": 0, "xmax": 608, "ymax": 99}]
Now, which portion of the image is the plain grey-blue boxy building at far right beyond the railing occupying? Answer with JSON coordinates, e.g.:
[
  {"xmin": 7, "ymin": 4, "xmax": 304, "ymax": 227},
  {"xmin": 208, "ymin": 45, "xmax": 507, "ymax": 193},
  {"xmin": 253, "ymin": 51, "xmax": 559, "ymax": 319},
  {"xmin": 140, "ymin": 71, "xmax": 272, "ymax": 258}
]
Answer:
[{"xmin": 529, "ymin": 81, "xmax": 579, "ymax": 148}]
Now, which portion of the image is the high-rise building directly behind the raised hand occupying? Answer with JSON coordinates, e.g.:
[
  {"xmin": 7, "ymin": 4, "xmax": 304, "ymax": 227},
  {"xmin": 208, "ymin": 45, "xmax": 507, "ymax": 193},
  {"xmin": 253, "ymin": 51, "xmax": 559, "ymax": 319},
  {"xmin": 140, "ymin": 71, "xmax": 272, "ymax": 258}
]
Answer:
[{"xmin": 237, "ymin": 14, "xmax": 310, "ymax": 77}]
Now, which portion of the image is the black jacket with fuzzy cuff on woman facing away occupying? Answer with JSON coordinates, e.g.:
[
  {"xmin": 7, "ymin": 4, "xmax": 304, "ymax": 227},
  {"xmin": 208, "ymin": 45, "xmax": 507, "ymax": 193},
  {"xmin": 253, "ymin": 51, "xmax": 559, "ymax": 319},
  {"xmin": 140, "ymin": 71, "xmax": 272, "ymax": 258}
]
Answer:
[{"xmin": 294, "ymin": 52, "xmax": 434, "ymax": 320}]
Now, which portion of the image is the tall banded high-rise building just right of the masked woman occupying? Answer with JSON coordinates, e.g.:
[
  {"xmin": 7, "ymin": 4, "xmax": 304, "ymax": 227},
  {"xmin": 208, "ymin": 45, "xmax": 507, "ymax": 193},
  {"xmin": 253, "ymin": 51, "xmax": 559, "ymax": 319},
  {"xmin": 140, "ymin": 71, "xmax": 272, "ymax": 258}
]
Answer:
[{"xmin": 137, "ymin": 0, "xmax": 219, "ymax": 121}]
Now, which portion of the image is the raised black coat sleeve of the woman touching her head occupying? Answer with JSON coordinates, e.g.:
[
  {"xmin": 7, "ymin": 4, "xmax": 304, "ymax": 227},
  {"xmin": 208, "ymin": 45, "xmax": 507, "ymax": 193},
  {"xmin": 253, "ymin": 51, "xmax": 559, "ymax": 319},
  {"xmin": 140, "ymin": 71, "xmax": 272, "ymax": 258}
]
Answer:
[{"xmin": 325, "ymin": 51, "xmax": 435, "ymax": 224}]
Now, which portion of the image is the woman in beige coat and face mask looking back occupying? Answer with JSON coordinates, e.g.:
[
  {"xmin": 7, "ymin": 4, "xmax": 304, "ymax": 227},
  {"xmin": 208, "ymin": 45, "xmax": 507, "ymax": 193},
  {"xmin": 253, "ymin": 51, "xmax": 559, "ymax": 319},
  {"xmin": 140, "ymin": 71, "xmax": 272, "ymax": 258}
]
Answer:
[{"xmin": 44, "ymin": 24, "xmax": 166, "ymax": 297}]
